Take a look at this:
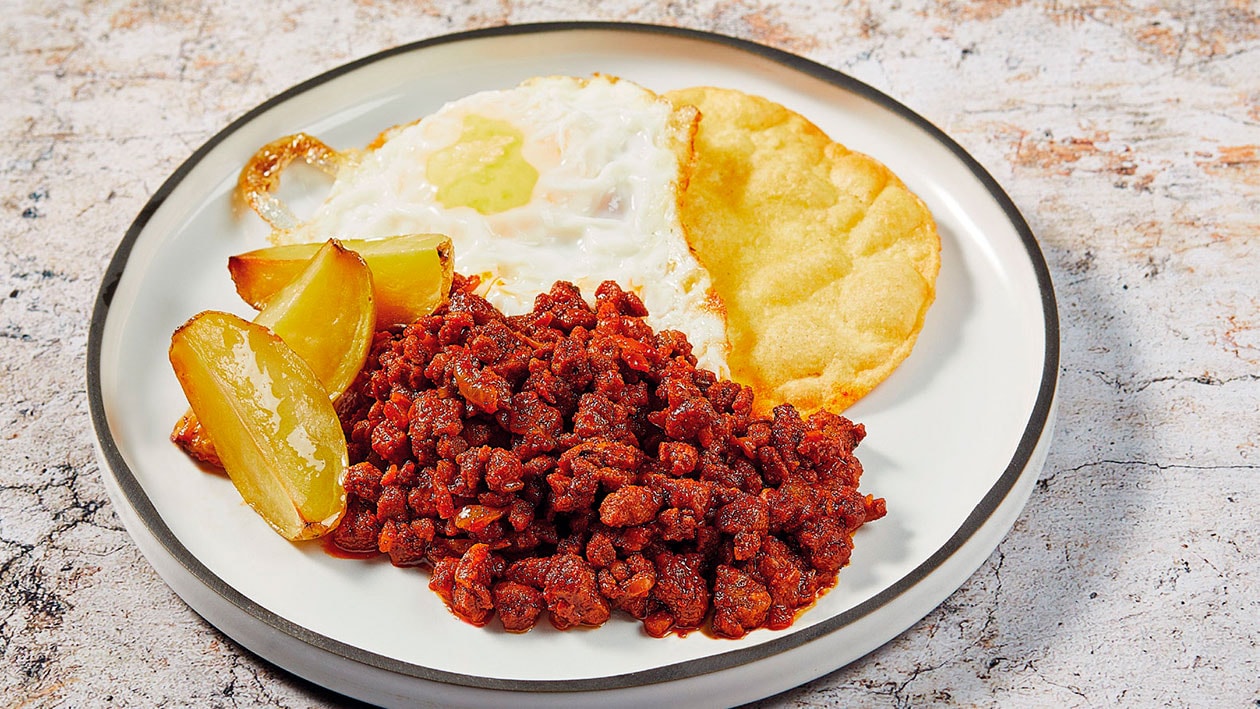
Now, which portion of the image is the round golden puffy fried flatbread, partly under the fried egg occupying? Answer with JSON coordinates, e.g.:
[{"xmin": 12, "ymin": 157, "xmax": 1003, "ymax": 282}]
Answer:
[{"xmin": 667, "ymin": 87, "xmax": 940, "ymax": 412}]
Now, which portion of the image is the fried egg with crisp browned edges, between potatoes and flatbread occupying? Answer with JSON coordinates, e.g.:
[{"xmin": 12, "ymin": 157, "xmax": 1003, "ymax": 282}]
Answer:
[{"xmin": 265, "ymin": 74, "xmax": 728, "ymax": 375}]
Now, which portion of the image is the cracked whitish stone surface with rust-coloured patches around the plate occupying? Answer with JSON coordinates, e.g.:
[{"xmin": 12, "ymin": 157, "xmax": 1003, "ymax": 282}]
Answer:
[{"xmin": 0, "ymin": 0, "xmax": 1260, "ymax": 706}]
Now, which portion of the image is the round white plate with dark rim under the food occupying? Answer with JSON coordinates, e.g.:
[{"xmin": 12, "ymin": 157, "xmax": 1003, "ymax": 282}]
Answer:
[{"xmin": 88, "ymin": 23, "xmax": 1058, "ymax": 706}]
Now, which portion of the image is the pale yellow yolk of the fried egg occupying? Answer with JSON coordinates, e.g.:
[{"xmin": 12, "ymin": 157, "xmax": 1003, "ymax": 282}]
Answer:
[{"xmin": 426, "ymin": 115, "xmax": 538, "ymax": 214}]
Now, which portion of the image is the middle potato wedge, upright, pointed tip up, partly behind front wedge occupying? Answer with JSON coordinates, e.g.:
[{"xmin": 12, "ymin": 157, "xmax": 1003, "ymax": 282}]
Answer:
[{"xmin": 170, "ymin": 239, "xmax": 375, "ymax": 467}]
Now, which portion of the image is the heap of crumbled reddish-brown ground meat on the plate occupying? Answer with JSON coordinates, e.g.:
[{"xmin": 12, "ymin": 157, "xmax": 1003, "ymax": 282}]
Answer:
[{"xmin": 333, "ymin": 277, "xmax": 885, "ymax": 637}]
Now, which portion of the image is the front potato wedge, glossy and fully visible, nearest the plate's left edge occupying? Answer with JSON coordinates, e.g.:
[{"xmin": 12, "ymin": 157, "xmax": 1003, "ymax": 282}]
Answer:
[{"xmin": 170, "ymin": 311, "xmax": 348, "ymax": 540}]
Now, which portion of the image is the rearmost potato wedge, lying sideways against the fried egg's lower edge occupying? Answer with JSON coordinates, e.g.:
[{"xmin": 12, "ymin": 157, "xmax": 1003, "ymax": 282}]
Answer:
[{"xmin": 228, "ymin": 234, "xmax": 454, "ymax": 326}]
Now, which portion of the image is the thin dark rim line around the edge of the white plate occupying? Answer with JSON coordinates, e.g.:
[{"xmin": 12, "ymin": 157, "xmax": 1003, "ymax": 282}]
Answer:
[{"xmin": 87, "ymin": 21, "xmax": 1058, "ymax": 691}]
